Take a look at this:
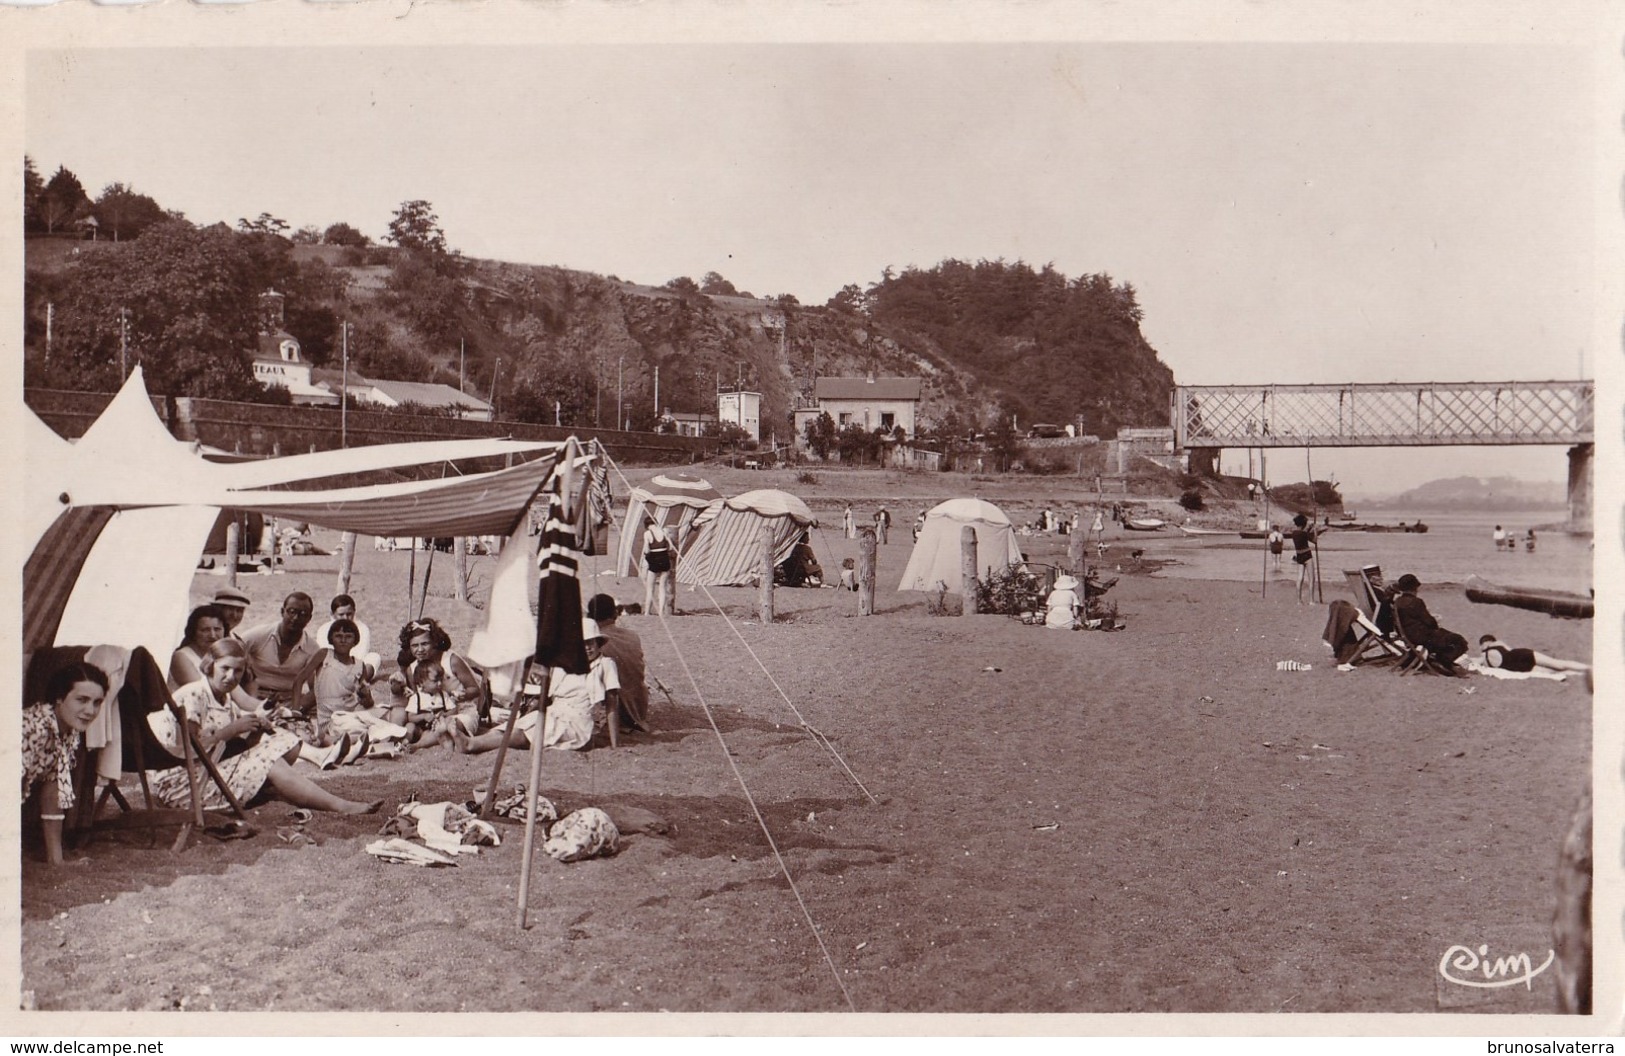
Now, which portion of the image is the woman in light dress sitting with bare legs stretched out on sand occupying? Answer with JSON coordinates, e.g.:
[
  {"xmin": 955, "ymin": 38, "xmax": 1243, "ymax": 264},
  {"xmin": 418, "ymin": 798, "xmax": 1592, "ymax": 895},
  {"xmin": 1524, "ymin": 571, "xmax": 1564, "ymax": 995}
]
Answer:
[{"xmin": 148, "ymin": 638, "xmax": 384, "ymax": 814}]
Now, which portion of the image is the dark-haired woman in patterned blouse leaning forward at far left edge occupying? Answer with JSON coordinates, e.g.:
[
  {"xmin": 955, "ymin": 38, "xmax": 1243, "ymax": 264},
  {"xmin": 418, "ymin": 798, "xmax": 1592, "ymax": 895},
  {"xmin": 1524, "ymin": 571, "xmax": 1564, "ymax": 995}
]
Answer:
[{"xmin": 23, "ymin": 661, "xmax": 107, "ymax": 866}]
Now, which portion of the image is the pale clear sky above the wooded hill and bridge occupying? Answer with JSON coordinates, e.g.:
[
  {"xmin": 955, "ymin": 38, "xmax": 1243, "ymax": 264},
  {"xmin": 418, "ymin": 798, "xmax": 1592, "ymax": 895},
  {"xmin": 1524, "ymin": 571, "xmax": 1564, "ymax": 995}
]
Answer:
[{"xmin": 23, "ymin": 42, "xmax": 1599, "ymax": 496}]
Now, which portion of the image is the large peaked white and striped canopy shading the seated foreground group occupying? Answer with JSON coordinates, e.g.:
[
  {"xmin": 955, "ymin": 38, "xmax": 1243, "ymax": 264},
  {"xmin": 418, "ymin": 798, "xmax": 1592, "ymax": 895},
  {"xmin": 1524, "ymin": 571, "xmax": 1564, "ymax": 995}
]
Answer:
[{"xmin": 21, "ymin": 367, "xmax": 578, "ymax": 656}]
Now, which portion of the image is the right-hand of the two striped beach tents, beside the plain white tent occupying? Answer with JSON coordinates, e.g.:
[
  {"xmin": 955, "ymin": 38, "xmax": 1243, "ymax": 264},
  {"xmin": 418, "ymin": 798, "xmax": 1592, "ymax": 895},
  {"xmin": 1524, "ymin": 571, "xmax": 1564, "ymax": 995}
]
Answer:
[{"xmin": 678, "ymin": 487, "xmax": 817, "ymax": 586}]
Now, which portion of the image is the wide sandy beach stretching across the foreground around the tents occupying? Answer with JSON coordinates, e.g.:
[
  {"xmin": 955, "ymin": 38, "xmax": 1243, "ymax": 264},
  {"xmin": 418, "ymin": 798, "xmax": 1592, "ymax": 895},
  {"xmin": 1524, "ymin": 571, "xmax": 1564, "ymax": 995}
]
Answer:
[{"xmin": 21, "ymin": 470, "xmax": 1591, "ymax": 1012}]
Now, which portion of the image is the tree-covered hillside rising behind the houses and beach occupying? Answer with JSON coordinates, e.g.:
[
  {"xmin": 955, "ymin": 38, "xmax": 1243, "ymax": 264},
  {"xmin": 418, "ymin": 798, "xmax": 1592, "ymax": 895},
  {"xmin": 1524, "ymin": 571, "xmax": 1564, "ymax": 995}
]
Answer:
[{"xmin": 24, "ymin": 159, "xmax": 1173, "ymax": 442}]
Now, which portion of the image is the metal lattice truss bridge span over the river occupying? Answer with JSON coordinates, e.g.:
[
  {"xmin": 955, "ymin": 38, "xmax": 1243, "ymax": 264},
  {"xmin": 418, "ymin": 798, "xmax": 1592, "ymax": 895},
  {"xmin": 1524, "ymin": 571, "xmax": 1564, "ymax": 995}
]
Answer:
[{"xmin": 1172, "ymin": 382, "xmax": 1596, "ymax": 450}]
